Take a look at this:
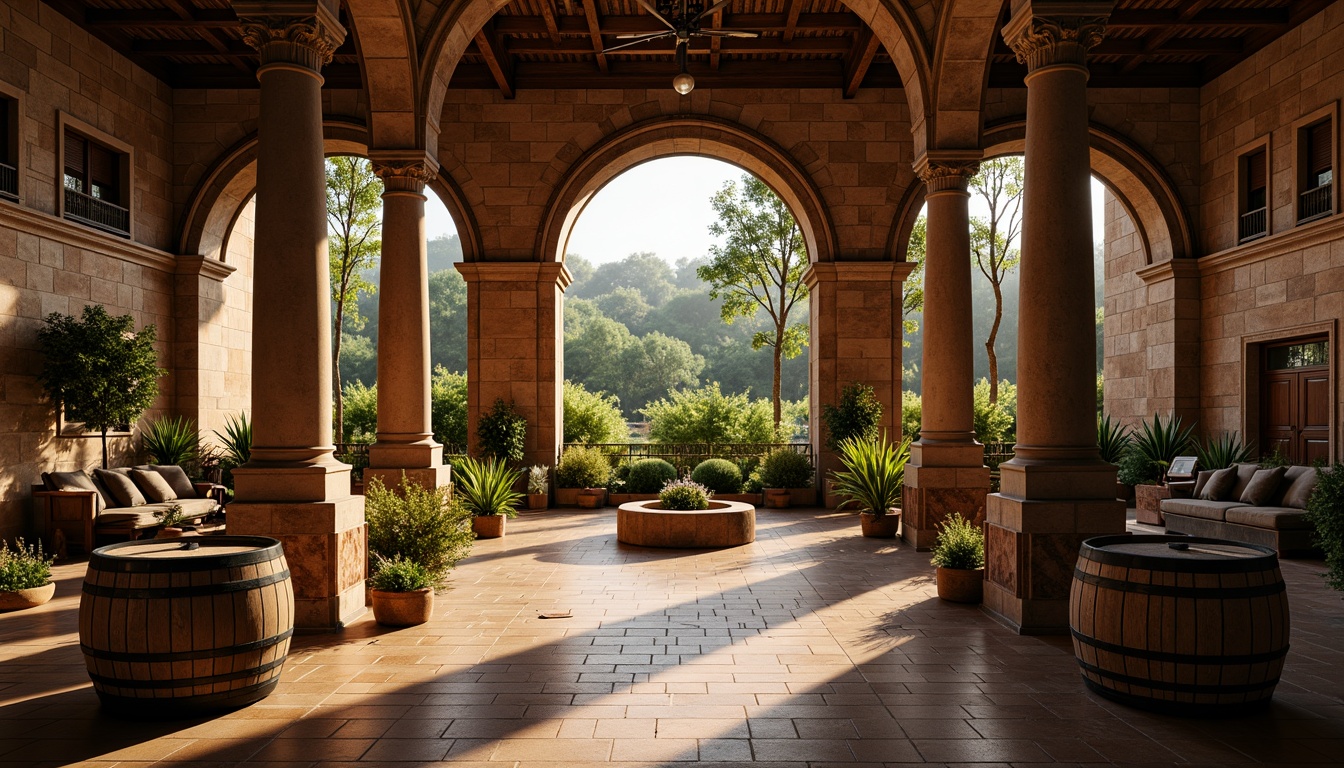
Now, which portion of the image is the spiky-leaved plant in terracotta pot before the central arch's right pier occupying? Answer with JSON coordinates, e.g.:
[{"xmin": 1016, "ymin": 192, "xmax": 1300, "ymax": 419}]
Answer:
[{"xmin": 831, "ymin": 436, "xmax": 910, "ymax": 538}]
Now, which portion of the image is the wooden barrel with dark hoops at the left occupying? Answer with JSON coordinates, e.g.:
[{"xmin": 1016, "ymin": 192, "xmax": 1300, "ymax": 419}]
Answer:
[{"xmin": 79, "ymin": 535, "xmax": 294, "ymax": 717}]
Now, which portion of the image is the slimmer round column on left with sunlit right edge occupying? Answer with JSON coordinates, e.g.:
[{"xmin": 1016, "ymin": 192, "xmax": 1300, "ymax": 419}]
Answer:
[{"xmin": 364, "ymin": 151, "xmax": 449, "ymax": 488}]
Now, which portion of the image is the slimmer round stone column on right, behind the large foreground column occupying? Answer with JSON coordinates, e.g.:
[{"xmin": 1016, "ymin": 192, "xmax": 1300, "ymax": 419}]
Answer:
[{"xmin": 900, "ymin": 156, "xmax": 989, "ymax": 549}]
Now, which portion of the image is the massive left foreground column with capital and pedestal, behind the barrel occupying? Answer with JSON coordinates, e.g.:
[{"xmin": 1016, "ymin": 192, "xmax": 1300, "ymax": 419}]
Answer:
[{"xmin": 228, "ymin": 1, "xmax": 366, "ymax": 628}]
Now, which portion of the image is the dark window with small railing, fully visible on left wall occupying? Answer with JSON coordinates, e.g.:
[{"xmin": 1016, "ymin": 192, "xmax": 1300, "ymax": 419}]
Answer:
[{"xmin": 63, "ymin": 126, "xmax": 130, "ymax": 235}]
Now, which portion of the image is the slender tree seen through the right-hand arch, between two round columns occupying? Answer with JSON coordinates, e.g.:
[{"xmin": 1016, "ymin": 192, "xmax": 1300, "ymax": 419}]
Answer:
[{"xmin": 970, "ymin": 157, "xmax": 1024, "ymax": 404}]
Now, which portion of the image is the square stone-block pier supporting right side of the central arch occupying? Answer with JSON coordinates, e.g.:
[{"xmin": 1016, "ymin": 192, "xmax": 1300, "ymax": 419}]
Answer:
[{"xmin": 802, "ymin": 261, "xmax": 914, "ymax": 497}]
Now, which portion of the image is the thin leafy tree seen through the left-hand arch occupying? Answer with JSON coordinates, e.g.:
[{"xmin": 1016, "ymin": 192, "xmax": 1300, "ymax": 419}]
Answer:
[{"xmin": 327, "ymin": 157, "xmax": 383, "ymax": 443}]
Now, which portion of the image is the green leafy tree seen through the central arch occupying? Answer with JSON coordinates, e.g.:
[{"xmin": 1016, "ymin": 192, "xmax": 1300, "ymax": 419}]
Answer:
[{"xmin": 695, "ymin": 175, "xmax": 808, "ymax": 428}]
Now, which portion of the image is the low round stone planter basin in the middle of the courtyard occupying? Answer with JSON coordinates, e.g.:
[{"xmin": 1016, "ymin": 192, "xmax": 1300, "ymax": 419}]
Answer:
[{"xmin": 616, "ymin": 499, "xmax": 755, "ymax": 549}]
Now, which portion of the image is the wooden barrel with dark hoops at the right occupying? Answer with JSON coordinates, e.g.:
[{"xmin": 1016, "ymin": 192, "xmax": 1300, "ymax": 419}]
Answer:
[{"xmin": 1068, "ymin": 535, "xmax": 1289, "ymax": 714}]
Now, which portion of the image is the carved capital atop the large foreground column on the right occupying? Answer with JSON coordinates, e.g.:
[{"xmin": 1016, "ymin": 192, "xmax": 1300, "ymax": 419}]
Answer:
[{"xmin": 1003, "ymin": 3, "xmax": 1114, "ymax": 73}]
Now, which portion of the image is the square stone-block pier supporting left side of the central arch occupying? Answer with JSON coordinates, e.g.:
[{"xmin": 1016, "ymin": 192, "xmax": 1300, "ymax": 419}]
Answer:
[{"xmin": 457, "ymin": 261, "xmax": 573, "ymax": 467}]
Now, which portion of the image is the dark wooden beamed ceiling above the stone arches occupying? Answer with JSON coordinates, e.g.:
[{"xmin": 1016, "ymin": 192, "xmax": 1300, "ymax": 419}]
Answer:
[{"xmin": 44, "ymin": 0, "xmax": 1332, "ymax": 97}]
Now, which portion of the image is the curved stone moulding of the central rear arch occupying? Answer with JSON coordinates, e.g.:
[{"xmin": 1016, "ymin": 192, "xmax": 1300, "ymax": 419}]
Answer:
[{"xmin": 535, "ymin": 116, "xmax": 837, "ymax": 262}]
